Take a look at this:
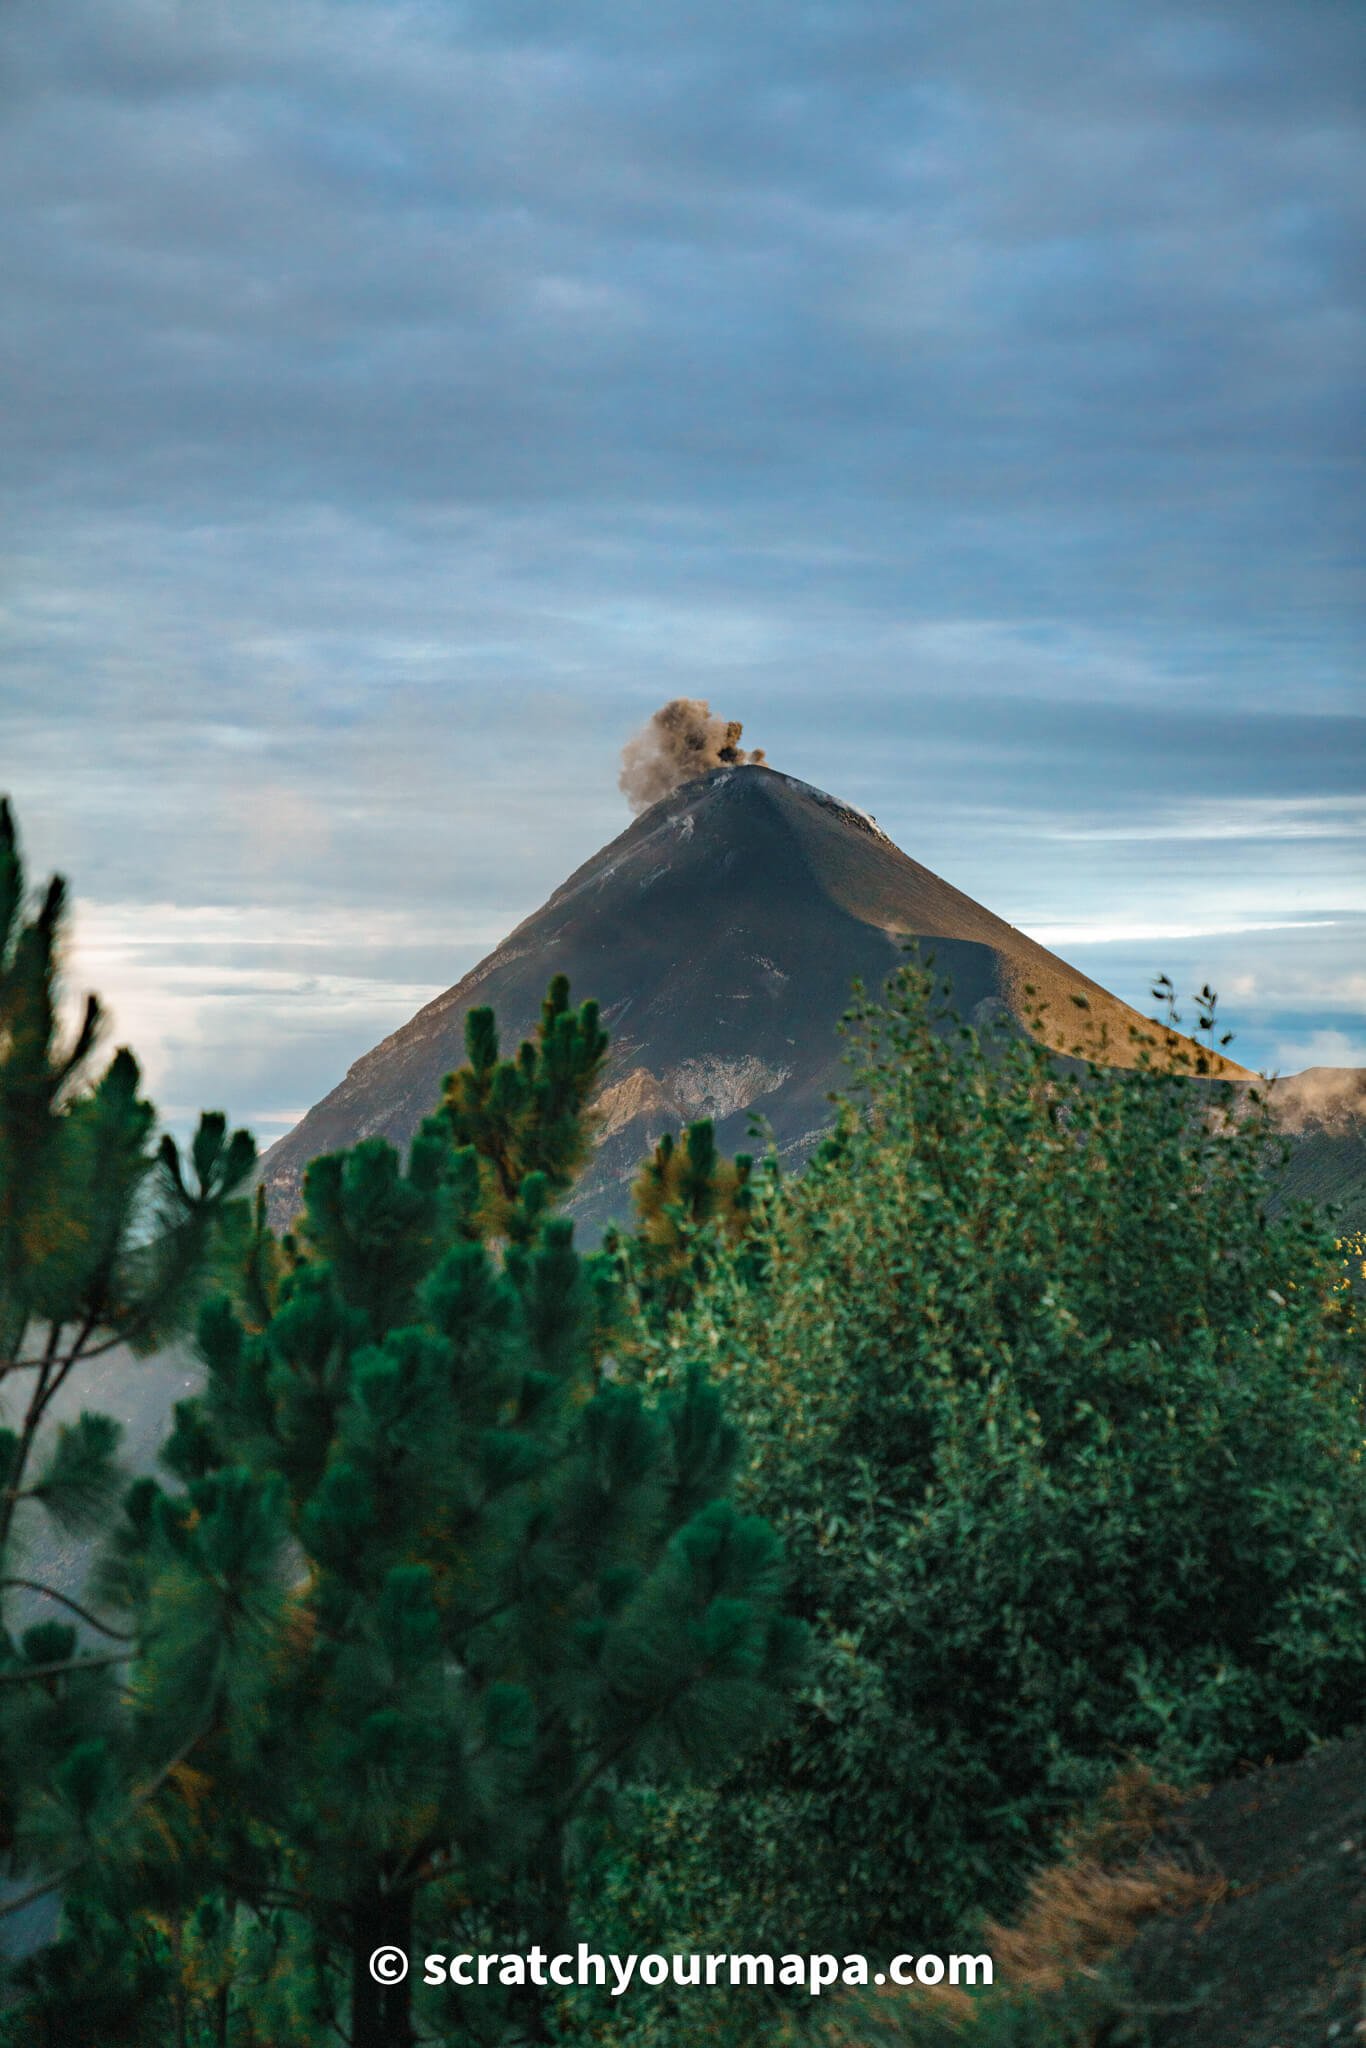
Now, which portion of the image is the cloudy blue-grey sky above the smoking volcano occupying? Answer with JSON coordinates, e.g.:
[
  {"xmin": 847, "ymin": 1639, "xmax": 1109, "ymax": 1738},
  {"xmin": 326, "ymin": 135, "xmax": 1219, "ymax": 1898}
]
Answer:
[{"xmin": 0, "ymin": 0, "xmax": 1366, "ymax": 1143}]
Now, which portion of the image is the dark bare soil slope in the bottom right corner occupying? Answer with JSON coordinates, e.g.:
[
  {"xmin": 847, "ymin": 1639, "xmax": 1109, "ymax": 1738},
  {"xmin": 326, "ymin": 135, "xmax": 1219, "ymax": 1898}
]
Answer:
[{"xmin": 1124, "ymin": 1735, "xmax": 1366, "ymax": 2048}]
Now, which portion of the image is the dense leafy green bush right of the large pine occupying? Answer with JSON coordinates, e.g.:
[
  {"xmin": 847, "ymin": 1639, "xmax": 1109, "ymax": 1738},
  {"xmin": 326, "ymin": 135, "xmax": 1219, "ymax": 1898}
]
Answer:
[{"xmin": 602, "ymin": 967, "xmax": 1366, "ymax": 1998}]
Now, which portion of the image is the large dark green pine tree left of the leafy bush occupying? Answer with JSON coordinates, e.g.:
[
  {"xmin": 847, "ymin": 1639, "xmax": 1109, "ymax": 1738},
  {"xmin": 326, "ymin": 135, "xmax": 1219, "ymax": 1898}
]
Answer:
[{"xmin": 69, "ymin": 981, "xmax": 801, "ymax": 2048}]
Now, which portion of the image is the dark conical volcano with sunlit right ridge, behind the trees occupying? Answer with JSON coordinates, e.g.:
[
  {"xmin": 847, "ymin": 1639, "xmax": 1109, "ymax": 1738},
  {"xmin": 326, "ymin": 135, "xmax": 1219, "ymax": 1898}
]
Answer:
[{"xmin": 262, "ymin": 766, "xmax": 1243, "ymax": 1225}]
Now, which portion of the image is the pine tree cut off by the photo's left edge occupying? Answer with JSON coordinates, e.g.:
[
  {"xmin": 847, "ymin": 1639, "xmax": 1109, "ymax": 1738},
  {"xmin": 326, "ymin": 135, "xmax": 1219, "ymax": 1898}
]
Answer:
[{"xmin": 0, "ymin": 803, "xmax": 256, "ymax": 1966}]
